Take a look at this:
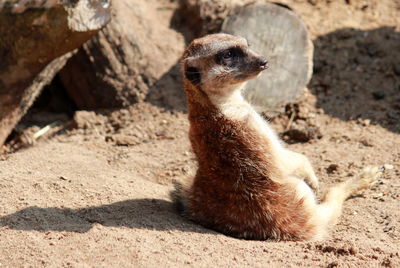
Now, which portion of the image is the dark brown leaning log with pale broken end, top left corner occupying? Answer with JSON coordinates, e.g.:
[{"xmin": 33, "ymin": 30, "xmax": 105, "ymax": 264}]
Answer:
[{"xmin": 0, "ymin": 0, "xmax": 110, "ymax": 148}]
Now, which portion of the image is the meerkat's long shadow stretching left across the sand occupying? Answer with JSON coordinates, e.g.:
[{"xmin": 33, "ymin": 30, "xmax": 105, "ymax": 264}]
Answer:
[{"xmin": 0, "ymin": 199, "xmax": 214, "ymax": 233}]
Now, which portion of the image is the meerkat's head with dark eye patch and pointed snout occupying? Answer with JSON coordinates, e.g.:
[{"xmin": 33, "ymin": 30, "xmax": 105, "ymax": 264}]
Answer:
[{"xmin": 182, "ymin": 34, "xmax": 268, "ymax": 96}]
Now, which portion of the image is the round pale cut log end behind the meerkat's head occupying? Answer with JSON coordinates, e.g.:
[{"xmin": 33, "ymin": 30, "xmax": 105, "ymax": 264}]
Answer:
[{"xmin": 222, "ymin": 3, "xmax": 313, "ymax": 115}]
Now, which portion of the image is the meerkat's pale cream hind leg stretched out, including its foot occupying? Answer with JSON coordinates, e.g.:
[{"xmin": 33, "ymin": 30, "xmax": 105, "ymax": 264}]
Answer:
[{"xmin": 315, "ymin": 166, "xmax": 383, "ymax": 239}]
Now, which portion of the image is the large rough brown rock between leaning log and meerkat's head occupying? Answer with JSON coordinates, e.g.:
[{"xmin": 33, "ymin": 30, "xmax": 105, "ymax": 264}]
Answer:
[{"xmin": 60, "ymin": 0, "xmax": 185, "ymax": 109}]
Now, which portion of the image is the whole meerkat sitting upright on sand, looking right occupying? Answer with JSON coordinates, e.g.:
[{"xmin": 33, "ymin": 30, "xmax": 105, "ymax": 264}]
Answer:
[{"xmin": 177, "ymin": 33, "xmax": 381, "ymax": 240}]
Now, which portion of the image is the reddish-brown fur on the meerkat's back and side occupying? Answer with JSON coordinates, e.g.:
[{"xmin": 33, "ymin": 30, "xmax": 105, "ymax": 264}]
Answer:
[{"xmin": 185, "ymin": 84, "xmax": 312, "ymax": 240}]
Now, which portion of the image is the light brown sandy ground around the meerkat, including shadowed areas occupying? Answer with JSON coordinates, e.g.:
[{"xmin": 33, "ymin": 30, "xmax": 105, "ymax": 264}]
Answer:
[{"xmin": 0, "ymin": 0, "xmax": 400, "ymax": 267}]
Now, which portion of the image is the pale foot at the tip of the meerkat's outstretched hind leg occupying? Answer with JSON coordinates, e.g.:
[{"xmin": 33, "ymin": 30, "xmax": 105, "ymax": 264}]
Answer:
[{"xmin": 348, "ymin": 166, "xmax": 383, "ymax": 194}]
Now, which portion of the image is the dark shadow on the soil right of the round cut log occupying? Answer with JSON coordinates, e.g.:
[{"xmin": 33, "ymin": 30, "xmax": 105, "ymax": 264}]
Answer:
[{"xmin": 309, "ymin": 27, "xmax": 400, "ymax": 133}]
